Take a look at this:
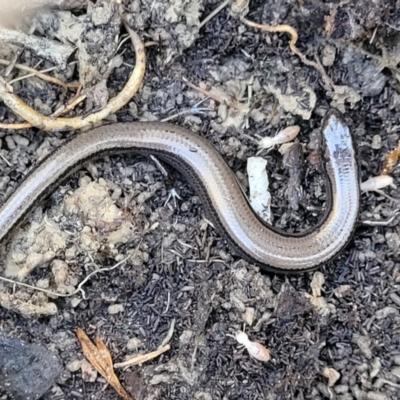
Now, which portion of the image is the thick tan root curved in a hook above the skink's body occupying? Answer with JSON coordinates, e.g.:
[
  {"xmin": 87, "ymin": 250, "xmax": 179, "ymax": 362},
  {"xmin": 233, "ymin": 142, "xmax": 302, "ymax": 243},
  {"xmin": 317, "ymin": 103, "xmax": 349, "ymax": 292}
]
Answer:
[{"xmin": 0, "ymin": 26, "xmax": 146, "ymax": 131}]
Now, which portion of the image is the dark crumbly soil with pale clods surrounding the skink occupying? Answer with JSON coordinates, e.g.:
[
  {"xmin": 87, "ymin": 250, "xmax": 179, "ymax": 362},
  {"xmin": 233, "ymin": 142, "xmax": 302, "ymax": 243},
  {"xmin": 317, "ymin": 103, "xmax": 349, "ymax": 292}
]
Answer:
[{"xmin": 0, "ymin": 0, "xmax": 400, "ymax": 400}]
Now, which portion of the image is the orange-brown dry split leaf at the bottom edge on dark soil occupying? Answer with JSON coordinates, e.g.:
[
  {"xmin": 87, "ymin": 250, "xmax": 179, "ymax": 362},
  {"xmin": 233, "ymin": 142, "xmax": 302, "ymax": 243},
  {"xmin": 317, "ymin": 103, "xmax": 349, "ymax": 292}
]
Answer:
[{"xmin": 76, "ymin": 328, "xmax": 134, "ymax": 400}]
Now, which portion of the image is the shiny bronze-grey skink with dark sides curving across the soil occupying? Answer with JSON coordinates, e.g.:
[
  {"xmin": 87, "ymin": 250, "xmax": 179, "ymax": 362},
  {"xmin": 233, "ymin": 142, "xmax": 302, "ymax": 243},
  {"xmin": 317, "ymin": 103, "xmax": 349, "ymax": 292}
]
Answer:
[{"xmin": 0, "ymin": 112, "xmax": 360, "ymax": 273}]
